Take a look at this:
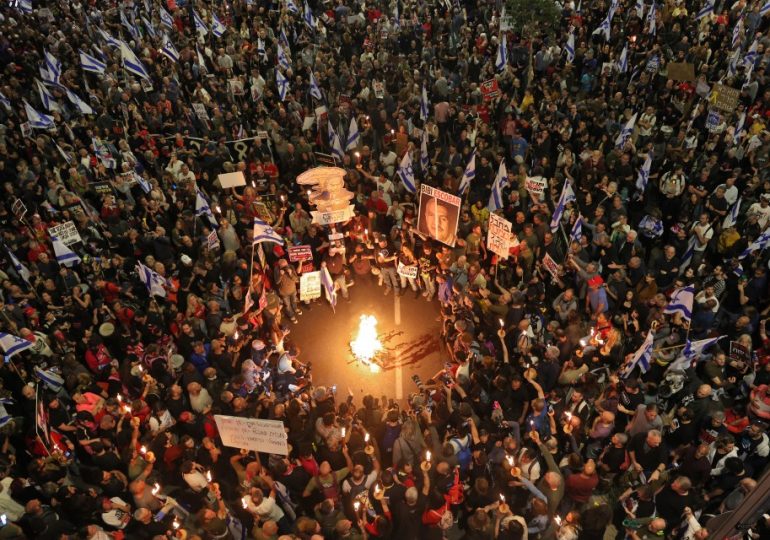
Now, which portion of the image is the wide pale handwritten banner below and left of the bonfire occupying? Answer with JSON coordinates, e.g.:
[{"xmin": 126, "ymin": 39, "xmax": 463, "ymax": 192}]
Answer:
[{"xmin": 214, "ymin": 414, "xmax": 289, "ymax": 456}]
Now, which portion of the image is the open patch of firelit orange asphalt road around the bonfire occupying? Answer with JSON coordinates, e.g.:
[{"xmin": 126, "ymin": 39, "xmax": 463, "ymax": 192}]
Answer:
[{"xmin": 289, "ymin": 283, "xmax": 444, "ymax": 405}]
